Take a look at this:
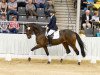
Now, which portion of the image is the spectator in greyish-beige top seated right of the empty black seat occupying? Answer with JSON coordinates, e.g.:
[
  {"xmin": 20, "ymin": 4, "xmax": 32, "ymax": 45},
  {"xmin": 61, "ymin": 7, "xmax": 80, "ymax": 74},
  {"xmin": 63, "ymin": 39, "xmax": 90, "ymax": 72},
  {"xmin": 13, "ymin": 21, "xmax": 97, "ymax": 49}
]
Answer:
[{"xmin": 26, "ymin": 0, "xmax": 38, "ymax": 18}]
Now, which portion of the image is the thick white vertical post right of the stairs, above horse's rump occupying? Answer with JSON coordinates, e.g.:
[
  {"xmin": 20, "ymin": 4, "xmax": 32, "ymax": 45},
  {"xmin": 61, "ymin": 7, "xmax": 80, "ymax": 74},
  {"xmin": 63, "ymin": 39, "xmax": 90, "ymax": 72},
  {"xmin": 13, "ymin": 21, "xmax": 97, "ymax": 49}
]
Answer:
[{"xmin": 76, "ymin": 0, "xmax": 81, "ymax": 33}]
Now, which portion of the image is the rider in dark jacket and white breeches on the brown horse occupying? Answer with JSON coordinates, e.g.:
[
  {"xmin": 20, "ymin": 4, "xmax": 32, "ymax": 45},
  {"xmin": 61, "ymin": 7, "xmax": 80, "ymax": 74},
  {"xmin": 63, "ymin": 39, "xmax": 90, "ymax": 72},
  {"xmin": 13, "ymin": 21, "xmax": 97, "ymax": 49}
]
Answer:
[{"xmin": 47, "ymin": 11, "xmax": 58, "ymax": 45}]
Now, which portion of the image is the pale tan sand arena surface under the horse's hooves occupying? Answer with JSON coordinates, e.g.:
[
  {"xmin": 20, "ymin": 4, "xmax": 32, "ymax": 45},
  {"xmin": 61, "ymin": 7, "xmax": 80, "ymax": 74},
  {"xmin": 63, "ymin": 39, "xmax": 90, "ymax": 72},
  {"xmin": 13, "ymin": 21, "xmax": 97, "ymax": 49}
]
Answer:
[{"xmin": 0, "ymin": 59, "xmax": 100, "ymax": 75}]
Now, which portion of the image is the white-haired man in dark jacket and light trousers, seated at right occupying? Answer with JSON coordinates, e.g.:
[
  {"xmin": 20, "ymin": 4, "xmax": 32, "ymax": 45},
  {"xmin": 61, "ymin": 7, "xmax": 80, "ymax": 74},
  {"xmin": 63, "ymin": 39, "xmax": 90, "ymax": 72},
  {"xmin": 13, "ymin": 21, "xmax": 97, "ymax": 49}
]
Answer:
[{"xmin": 81, "ymin": 10, "xmax": 92, "ymax": 29}]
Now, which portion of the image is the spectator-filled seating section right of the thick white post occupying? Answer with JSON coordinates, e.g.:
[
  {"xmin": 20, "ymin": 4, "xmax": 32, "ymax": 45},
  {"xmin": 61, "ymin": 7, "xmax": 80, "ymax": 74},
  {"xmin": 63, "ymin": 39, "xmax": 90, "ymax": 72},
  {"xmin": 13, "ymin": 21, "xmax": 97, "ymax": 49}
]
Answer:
[{"xmin": 80, "ymin": 0, "xmax": 100, "ymax": 37}]
